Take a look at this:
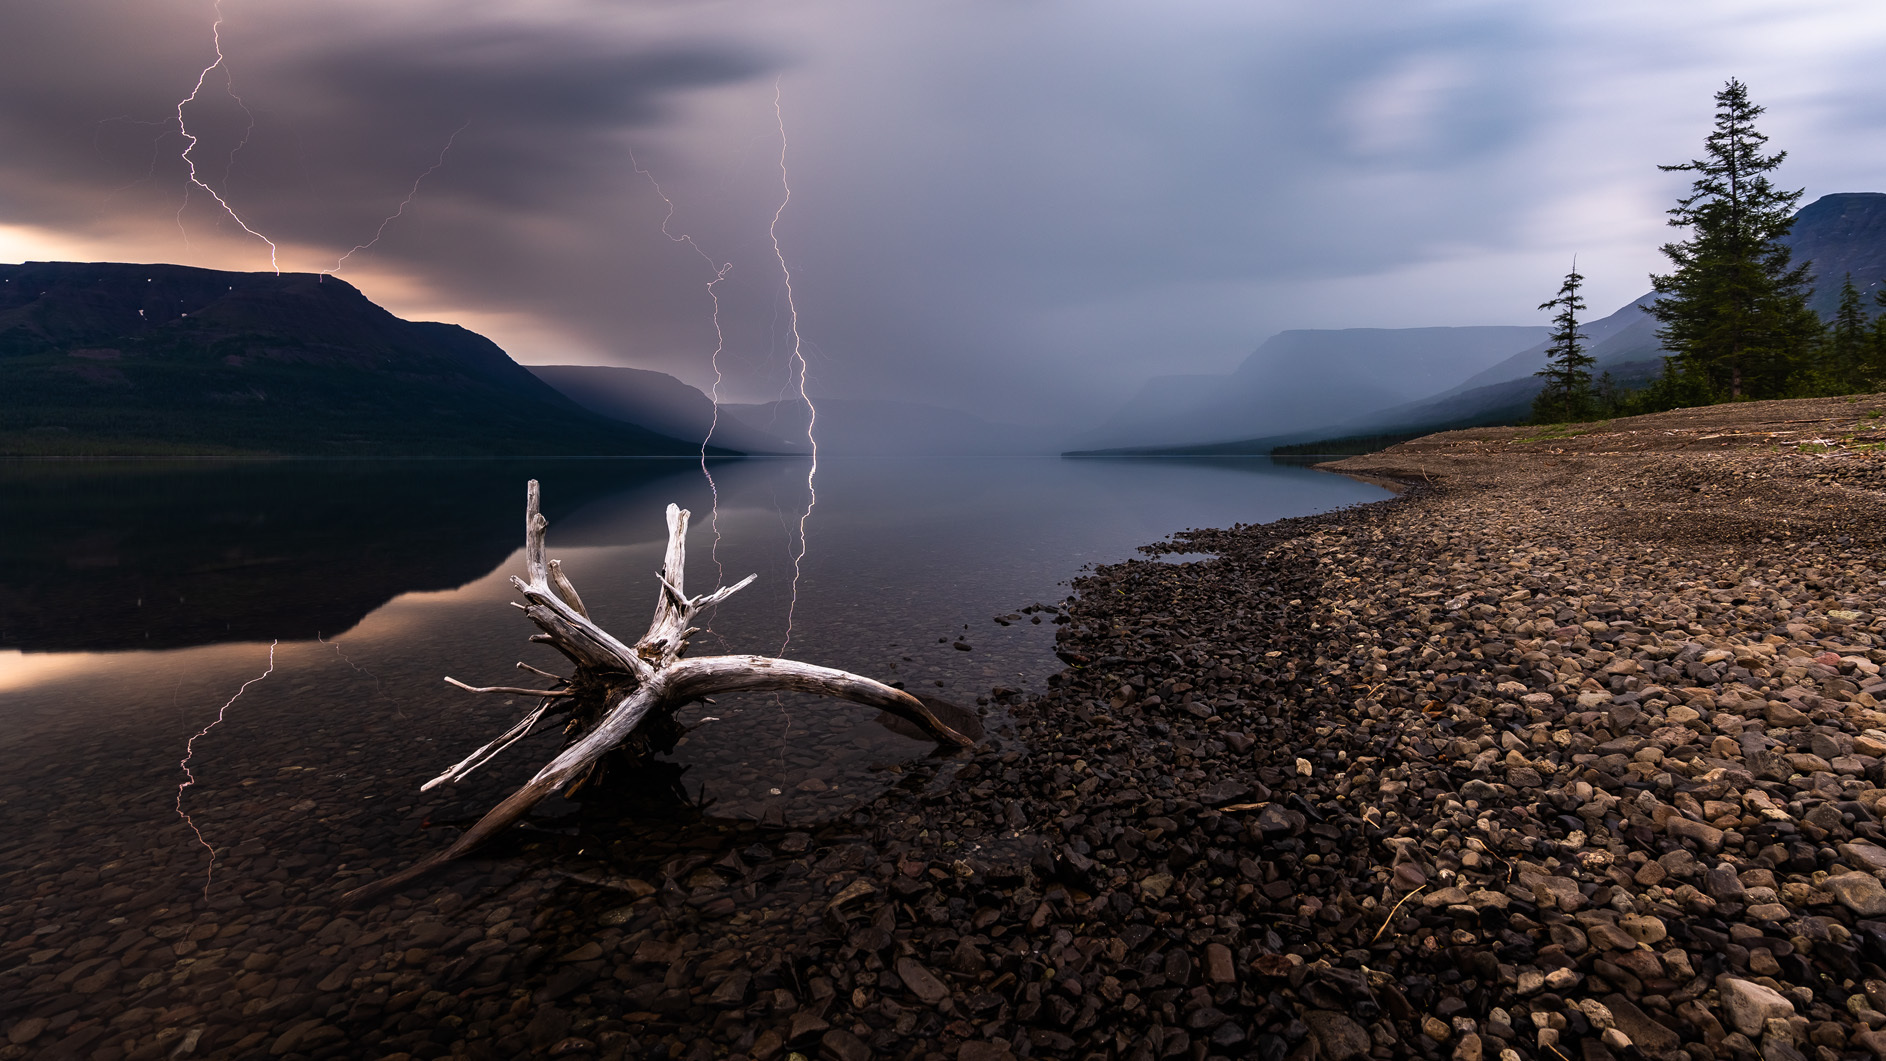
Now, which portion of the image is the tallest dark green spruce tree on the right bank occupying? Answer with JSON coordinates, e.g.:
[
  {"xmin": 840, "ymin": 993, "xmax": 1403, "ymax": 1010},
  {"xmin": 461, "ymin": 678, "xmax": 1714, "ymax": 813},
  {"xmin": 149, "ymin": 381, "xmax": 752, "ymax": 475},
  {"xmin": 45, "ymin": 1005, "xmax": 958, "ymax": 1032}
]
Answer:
[{"xmin": 1650, "ymin": 79, "xmax": 1820, "ymax": 400}]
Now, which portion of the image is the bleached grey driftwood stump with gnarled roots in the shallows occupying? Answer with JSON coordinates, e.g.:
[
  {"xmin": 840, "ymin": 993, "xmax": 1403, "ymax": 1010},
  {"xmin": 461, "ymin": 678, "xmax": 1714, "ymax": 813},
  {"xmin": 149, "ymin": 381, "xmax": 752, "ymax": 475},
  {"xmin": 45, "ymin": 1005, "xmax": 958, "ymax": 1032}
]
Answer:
[{"xmin": 343, "ymin": 479, "xmax": 971, "ymax": 903}]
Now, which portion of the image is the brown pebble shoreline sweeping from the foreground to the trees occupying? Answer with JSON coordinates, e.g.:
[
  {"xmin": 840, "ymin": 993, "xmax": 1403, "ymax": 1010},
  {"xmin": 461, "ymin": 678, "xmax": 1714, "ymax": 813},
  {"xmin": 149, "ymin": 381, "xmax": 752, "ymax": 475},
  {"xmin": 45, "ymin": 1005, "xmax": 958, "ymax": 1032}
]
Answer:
[{"xmin": 18, "ymin": 396, "xmax": 1886, "ymax": 1061}]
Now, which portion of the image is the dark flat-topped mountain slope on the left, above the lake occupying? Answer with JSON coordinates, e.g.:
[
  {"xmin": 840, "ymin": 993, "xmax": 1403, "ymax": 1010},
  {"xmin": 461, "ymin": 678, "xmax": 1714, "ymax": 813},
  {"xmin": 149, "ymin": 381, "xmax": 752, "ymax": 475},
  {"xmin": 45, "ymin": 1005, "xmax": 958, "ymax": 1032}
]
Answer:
[{"xmin": 0, "ymin": 262, "xmax": 712, "ymax": 456}]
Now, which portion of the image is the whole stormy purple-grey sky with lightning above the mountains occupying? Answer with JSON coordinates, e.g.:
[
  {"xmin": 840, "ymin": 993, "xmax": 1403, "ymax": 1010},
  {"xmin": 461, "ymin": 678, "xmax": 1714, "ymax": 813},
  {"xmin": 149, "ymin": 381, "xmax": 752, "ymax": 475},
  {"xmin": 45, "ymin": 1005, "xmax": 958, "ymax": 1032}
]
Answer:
[{"xmin": 0, "ymin": 0, "xmax": 1886, "ymax": 428}]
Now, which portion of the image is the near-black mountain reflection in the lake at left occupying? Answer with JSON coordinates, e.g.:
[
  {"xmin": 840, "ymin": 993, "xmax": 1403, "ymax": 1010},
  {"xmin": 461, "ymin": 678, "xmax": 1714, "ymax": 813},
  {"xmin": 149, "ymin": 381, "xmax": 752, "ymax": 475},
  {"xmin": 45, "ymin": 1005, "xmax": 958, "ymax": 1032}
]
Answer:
[{"xmin": 0, "ymin": 458, "xmax": 700, "ymax": 652}]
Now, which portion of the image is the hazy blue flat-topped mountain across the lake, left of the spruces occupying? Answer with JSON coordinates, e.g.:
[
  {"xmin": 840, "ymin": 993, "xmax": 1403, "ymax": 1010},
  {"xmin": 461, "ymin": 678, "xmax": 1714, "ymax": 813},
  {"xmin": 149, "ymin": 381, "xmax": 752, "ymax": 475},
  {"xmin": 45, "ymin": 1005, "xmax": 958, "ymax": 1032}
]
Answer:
[{"xmin": 1075, "ymin": 326, "xmax": 1548, "ymax": 449}]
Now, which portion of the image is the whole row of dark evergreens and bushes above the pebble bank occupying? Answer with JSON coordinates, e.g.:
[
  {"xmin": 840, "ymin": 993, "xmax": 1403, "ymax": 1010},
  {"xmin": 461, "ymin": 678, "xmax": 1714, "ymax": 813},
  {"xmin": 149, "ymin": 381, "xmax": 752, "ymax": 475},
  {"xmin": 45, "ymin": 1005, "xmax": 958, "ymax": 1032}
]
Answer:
[{"xmin": 1533, "ymin": 79, "xmax": 1886, "ymax": 424}]
